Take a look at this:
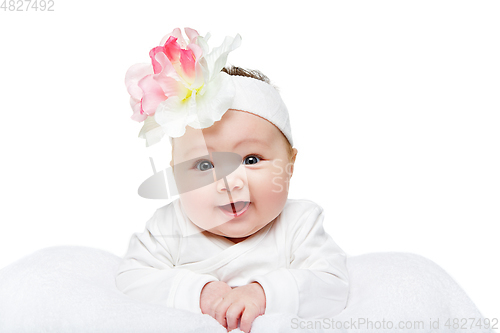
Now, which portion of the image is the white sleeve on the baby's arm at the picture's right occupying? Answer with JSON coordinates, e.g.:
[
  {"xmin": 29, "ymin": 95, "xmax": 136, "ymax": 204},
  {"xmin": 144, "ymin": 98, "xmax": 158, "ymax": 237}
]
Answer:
[{"xmin": 249, "ymin": 206, "xmax": 349, "ymax": 318}]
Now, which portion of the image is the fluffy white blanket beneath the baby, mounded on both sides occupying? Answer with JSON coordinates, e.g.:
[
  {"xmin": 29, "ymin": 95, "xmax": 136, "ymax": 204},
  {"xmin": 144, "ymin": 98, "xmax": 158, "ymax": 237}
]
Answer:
[{"xmin": 0, "ymin": 246, "xmax": 491, "ymax": 333}]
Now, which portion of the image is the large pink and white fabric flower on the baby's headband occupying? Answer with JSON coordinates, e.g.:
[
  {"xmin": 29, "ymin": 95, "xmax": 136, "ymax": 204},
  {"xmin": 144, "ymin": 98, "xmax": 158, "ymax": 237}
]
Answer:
[{"xmin": 125, "ymin": 28, "xmax": 241, "ymax": 146}]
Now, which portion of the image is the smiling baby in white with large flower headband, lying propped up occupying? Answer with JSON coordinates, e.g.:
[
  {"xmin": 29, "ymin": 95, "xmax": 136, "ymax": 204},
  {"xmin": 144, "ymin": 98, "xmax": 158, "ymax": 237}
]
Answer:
[{"xmin": 116, "ymin": 28, "xmax": 349, "ymax": 332}]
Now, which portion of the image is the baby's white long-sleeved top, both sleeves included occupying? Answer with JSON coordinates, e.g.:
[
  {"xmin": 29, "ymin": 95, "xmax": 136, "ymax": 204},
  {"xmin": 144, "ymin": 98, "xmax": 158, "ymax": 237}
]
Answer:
[{"xmin": 116, "ymin": 199, "xmax": 349, "ymax": 318}]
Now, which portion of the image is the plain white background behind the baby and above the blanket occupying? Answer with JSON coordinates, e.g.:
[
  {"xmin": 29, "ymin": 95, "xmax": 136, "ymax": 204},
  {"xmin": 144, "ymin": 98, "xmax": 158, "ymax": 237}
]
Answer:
[{"xmin": 0, "ymin": 0, "xmax": 500, "ymax": 318}]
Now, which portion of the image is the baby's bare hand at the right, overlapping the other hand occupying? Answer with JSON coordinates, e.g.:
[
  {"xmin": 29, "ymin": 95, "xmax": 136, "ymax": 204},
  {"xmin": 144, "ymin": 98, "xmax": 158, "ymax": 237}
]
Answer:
[{"xmin": 212, "ymin": 282, "xmax": 266, "ymax": 333}]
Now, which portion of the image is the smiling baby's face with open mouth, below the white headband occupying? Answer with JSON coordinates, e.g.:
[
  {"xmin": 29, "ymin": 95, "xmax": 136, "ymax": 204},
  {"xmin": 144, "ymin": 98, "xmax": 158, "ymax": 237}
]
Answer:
[{"xmin": 172, "ymin": 110, "xmax": 297, "ymax": 242}]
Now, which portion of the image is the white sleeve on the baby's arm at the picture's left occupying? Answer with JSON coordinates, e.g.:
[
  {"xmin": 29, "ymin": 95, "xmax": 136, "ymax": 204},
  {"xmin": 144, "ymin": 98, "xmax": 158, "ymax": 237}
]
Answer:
[{"xmin": 116, "ymin": 210, "xmax": 217, "ymax": 314}]
